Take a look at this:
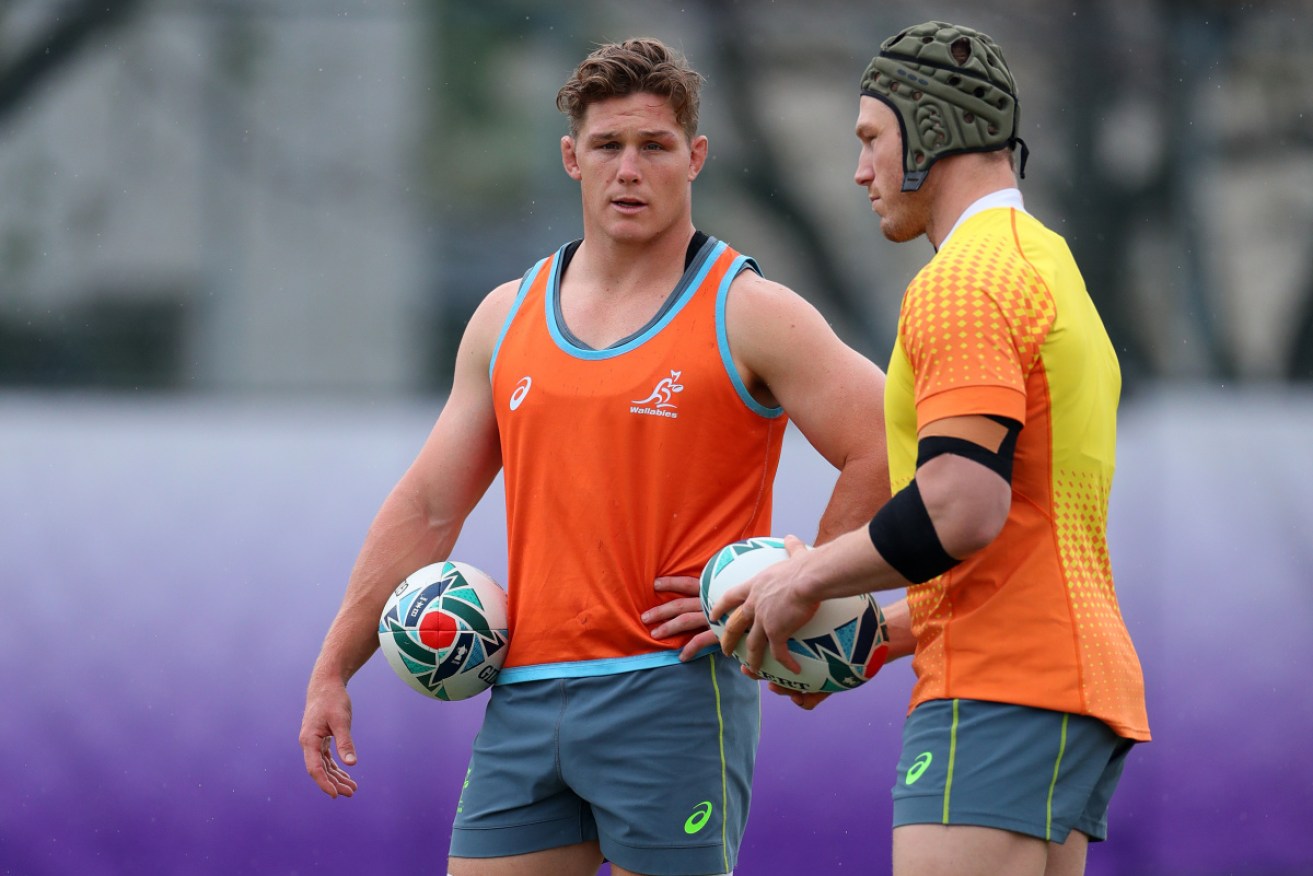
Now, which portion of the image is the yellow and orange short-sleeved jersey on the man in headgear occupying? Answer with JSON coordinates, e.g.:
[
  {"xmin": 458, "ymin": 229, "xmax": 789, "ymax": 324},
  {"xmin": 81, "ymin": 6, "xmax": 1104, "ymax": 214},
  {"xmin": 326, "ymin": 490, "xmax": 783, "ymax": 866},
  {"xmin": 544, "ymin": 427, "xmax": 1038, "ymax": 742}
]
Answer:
[{"xmin": 885, "ymin": 208, "xmax": 1149, "ymax": 739}]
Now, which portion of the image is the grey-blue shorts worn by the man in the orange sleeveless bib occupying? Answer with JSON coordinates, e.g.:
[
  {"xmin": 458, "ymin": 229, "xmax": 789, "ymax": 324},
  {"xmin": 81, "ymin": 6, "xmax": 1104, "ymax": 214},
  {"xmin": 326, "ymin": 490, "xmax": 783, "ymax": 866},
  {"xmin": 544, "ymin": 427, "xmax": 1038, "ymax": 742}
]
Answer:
[{"xmin": 452, "ymin": 651, "xmax": 762, "ymax": 876}]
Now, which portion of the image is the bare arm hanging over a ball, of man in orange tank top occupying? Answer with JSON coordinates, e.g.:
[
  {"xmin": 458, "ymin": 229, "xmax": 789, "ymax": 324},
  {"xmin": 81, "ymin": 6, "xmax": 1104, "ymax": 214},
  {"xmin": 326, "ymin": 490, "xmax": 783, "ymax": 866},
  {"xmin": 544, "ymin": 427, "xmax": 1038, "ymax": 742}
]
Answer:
[{"xmin": 301, "ymin": 284, "xmax": 516, "ymax": 796}]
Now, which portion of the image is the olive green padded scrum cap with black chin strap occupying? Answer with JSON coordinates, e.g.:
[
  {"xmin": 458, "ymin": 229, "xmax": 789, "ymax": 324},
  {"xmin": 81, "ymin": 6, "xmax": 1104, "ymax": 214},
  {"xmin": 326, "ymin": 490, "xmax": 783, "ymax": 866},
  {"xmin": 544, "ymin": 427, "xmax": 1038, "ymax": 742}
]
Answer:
[{"xmin": 861, "ymin": 21, "xmax": 1029, "ymax": 192}]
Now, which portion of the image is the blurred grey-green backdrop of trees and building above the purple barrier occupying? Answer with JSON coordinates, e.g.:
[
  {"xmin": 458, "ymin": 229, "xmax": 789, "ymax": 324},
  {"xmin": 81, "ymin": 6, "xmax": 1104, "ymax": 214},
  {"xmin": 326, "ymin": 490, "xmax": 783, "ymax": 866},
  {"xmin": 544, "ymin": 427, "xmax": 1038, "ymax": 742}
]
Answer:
[{"xmin": 0, "ymin": 0, "xmax": 1313, "ymax": 398}]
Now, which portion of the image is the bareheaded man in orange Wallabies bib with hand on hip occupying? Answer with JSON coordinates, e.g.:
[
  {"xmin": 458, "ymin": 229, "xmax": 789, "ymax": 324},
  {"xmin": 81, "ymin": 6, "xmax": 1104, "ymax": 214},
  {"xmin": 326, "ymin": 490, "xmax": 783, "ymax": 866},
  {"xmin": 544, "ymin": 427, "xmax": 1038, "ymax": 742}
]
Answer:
[{"xmin": 301, "ymin": 39, "xmax": 888, "ymax": 876}]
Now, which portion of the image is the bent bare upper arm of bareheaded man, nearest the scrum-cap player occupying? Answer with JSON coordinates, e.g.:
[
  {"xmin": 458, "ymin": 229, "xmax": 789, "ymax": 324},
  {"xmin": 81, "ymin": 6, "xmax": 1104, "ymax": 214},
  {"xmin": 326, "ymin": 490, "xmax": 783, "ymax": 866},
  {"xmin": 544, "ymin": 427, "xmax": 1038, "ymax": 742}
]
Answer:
[{"xmin": 726, "ymin": 272, "xmax": 889, "ymax": 544}]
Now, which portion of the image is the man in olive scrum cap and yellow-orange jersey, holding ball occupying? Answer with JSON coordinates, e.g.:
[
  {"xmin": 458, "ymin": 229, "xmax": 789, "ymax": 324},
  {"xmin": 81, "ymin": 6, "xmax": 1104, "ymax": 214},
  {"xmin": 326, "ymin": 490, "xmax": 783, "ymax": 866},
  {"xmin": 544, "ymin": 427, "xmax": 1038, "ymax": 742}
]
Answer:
[{"xmin": 712, "ymin": 21, "xmax": 1149, "ymax": 876}]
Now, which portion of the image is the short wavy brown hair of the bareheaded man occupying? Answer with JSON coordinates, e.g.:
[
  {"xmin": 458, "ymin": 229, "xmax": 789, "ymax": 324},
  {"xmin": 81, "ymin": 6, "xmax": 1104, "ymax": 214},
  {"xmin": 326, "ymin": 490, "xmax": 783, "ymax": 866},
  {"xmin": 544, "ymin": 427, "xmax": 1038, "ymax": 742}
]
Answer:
[{"xmin": 557, "ymin": 37, "xmax": 702, "ymax": 141}]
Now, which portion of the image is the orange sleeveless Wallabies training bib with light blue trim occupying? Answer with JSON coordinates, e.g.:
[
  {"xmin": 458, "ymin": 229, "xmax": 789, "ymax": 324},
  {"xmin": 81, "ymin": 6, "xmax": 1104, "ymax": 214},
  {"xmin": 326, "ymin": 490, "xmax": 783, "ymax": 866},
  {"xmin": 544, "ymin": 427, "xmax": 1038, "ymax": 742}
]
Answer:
[{"xmin": 490, "ymin": 238, "xmax": 786, "ymax": 683}]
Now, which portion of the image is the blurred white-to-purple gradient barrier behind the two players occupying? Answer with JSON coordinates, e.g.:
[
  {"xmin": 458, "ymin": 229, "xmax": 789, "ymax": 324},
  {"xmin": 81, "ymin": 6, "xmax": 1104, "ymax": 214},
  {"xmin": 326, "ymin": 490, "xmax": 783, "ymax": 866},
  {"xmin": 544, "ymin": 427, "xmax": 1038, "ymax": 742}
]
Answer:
[{"xmin": 0, "ymin": 390, "xmax": 1313, "ymax": 876}]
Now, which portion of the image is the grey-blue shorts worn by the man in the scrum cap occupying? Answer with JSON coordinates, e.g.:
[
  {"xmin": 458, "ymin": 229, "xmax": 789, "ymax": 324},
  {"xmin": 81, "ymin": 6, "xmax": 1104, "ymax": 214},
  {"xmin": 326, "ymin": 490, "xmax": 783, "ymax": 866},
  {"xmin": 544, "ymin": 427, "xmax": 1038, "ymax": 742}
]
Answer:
[{"xmin": 893, "ymin": 700, "xmax": 1133, "ymax": 843}]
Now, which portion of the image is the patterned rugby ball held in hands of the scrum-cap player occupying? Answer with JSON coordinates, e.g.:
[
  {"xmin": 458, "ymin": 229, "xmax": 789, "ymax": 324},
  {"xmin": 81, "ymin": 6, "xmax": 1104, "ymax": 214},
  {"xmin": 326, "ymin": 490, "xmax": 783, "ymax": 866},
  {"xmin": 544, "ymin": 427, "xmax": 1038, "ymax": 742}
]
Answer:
[{"xmin": 699, "ymin": 537, "xmax": 889, "ymax": 693}]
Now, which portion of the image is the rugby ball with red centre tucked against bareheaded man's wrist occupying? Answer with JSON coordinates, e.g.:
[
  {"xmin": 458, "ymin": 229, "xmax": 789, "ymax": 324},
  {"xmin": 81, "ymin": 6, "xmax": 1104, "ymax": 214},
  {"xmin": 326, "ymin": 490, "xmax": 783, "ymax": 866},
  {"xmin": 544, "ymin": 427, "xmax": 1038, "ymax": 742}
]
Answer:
[{"xmin": 378, "ymin": 562, "xmax": 508, "ymax": 700}]
